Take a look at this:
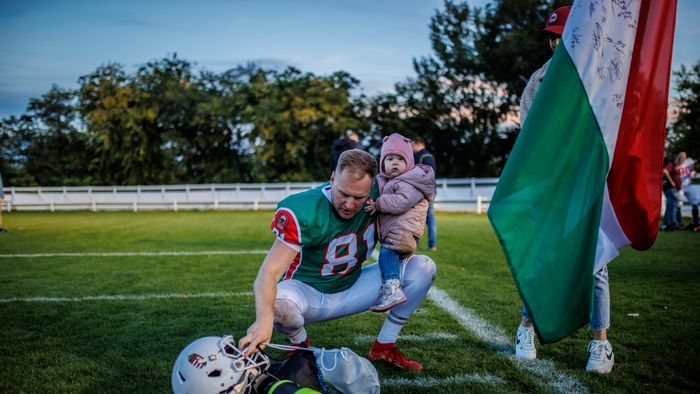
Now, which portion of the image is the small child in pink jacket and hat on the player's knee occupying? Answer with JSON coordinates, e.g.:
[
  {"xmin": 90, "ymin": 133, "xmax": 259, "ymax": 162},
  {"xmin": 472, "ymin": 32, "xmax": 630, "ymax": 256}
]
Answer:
[{"xmin": 365, "ymin": 133, "xmax": 435, "ymax": 312}]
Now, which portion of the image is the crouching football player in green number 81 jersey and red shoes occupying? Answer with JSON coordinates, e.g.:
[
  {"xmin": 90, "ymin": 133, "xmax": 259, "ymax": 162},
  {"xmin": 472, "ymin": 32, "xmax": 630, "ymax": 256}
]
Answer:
[{"xmin": 239, "ymin": 149, "xmax": 436, "ymax": 372}]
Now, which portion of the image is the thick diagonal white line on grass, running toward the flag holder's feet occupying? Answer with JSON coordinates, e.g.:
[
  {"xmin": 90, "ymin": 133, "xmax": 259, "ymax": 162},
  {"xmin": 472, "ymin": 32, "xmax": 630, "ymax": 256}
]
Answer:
[{"xmin": 428, "ymin": 286, "xmax": 588, "ymax": 393}]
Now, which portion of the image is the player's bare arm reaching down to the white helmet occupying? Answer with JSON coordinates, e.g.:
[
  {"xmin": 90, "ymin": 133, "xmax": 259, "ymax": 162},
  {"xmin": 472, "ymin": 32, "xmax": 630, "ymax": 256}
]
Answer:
[{"xmin": 238, "ymin": 240, "xmax": 297, "ymax": 356}]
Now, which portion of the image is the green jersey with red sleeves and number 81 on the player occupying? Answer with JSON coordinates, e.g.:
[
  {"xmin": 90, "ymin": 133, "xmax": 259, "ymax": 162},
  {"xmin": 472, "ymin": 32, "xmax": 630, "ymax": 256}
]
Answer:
[{"xmin": 270, "ymin": 183, "xmax": 379, "ymax": 293}]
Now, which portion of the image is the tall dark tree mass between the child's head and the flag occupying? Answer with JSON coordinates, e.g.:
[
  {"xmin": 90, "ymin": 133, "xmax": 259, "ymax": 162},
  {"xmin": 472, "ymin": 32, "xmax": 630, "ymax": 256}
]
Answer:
[{"xmin": 370, "ymin": 0, "xmax": 554, "ymax": 177}]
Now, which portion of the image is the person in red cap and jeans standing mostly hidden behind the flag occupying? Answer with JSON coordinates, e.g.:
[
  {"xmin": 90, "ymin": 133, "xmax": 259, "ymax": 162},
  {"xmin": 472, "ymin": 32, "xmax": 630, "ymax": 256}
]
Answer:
[{"xmin": 515, "ymin": 6, "xmax": 615, "ymax": 373}]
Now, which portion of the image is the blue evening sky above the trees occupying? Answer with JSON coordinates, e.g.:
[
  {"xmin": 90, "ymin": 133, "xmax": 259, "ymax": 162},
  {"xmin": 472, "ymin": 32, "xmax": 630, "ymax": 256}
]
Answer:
[{"xmin": 0, "ymin": 0, "xmax": 700, "ymax": 118}]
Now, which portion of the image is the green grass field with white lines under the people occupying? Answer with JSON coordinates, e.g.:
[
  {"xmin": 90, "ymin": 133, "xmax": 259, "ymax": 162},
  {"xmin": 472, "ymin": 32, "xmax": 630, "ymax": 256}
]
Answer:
[{"xmin": 0, "ymin": 212, "xmax": 700, "ymax": 393}]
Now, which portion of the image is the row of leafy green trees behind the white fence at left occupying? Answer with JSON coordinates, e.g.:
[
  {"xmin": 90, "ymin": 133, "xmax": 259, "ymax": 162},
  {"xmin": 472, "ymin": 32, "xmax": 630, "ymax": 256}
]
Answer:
[{"xmin": 0, "ymin": 56, "xmax": 364, "ymax": 186}]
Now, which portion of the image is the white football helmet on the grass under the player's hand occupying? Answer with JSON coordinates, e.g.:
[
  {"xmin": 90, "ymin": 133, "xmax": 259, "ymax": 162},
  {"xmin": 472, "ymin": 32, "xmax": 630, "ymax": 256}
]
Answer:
[{"xmin": 171, "ymin": 335, "xmax": 270, "ymax": 394}]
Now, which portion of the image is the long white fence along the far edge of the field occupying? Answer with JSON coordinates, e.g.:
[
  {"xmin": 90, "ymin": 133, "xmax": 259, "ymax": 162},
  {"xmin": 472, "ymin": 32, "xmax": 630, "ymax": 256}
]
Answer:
[{"xmin": 3, "ymin": 178, "xmax": 498, "ymax": 213}]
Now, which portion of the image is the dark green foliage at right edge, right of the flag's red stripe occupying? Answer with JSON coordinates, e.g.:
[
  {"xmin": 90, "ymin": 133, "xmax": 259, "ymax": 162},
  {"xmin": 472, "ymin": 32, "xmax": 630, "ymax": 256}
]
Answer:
[{"xmin": 668, "ymin": 61, "xmax": 700, "ymax": 160}]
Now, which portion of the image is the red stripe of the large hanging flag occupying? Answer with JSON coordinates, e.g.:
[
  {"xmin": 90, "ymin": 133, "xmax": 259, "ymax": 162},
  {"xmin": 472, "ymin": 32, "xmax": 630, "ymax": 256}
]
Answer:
[{"xmin": 607, "ymin": 0, "xmax": 676, "ymax": 250}]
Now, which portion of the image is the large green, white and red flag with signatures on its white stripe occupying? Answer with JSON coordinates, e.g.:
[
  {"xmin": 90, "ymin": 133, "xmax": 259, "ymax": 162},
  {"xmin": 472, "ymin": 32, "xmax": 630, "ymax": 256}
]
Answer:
[{"xmin": 488, "ymin": 0, "xmax": 676, "ymax": 343}]
